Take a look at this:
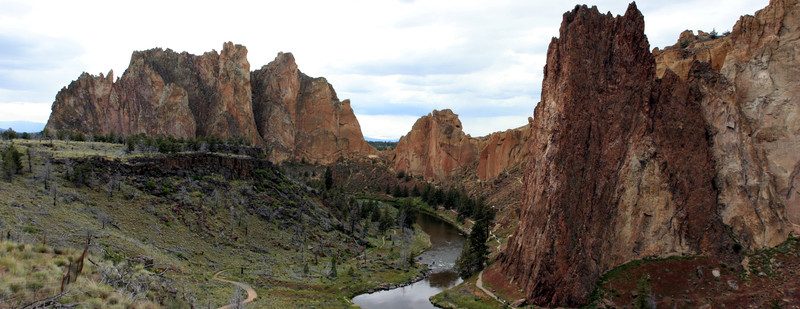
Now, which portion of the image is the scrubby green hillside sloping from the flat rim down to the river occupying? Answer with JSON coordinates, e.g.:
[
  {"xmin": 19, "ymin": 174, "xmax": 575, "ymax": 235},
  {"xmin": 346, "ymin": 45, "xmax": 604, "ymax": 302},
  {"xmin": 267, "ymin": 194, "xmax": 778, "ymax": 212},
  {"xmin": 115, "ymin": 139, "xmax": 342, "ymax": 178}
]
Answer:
[{"xmin": 0, "ymin": 139, "xmax": 426, "ymax": 308}]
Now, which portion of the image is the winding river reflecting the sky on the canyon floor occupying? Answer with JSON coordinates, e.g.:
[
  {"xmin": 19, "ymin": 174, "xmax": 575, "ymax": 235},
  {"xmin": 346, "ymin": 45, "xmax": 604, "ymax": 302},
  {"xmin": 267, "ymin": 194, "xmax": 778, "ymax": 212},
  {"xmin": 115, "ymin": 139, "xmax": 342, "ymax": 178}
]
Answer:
[{"xmin": 353, "ymin": 214, "xmax": 465, "ymax": 309}]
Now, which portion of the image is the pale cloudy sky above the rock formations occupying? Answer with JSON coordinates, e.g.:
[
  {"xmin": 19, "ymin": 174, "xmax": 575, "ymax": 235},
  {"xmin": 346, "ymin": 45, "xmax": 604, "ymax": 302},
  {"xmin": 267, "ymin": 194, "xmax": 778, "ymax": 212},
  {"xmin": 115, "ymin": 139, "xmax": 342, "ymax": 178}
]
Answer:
[{"xmin": 0, "ymin": 0, "xmax": 769, "ymax": 139}]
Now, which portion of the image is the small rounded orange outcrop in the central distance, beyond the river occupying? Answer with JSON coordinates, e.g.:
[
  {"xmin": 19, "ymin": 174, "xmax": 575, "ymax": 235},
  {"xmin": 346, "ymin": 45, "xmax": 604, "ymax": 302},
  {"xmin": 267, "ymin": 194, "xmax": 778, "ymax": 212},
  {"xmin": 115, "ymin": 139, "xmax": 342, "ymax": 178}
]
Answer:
[{"xmin": 390, "ymin": 109, "xmax": 478, "ymax": 181}]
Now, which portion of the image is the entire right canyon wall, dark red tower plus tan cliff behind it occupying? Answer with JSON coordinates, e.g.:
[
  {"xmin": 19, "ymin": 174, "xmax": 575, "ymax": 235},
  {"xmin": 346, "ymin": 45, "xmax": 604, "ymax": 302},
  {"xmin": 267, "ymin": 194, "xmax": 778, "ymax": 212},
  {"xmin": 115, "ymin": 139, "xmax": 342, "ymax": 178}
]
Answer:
[{"xmin": 499, "ymin": 0, "xmax": 800, "ymax": 306}]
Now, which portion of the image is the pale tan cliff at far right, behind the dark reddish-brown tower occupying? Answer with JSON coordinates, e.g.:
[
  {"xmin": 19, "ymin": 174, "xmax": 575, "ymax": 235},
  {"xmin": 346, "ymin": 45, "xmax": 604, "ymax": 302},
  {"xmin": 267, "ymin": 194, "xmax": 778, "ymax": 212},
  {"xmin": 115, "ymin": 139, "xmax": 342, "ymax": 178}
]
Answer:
[{"xmin": 654, "ymin": 0, "xmax": 800, "ymax": 249}]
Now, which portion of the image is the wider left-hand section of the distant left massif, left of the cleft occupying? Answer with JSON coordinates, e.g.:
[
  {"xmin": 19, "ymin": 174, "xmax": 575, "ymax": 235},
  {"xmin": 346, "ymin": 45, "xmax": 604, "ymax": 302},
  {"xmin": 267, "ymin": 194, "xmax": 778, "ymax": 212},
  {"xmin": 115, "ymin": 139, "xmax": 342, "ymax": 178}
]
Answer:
[{"xmin": 47, "ymin": 43, "xmax": 261, "ymax": 144}]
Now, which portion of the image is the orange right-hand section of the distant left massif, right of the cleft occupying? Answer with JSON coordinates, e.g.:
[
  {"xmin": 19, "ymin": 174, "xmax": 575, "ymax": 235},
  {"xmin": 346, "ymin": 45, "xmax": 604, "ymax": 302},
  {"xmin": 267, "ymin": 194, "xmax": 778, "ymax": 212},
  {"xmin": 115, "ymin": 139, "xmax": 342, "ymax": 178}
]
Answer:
[{"xmin": 252, "ymin": 53, "xmax": 375, "ymax": 164}]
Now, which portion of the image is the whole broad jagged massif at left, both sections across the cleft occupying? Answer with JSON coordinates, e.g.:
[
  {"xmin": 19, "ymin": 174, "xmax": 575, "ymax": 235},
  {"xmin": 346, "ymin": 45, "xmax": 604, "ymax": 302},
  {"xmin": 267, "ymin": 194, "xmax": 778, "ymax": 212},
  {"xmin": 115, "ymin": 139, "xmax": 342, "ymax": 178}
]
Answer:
[{"xmin": 47, "ymin": 43, "xmax": 375, "ymax": 164}]
